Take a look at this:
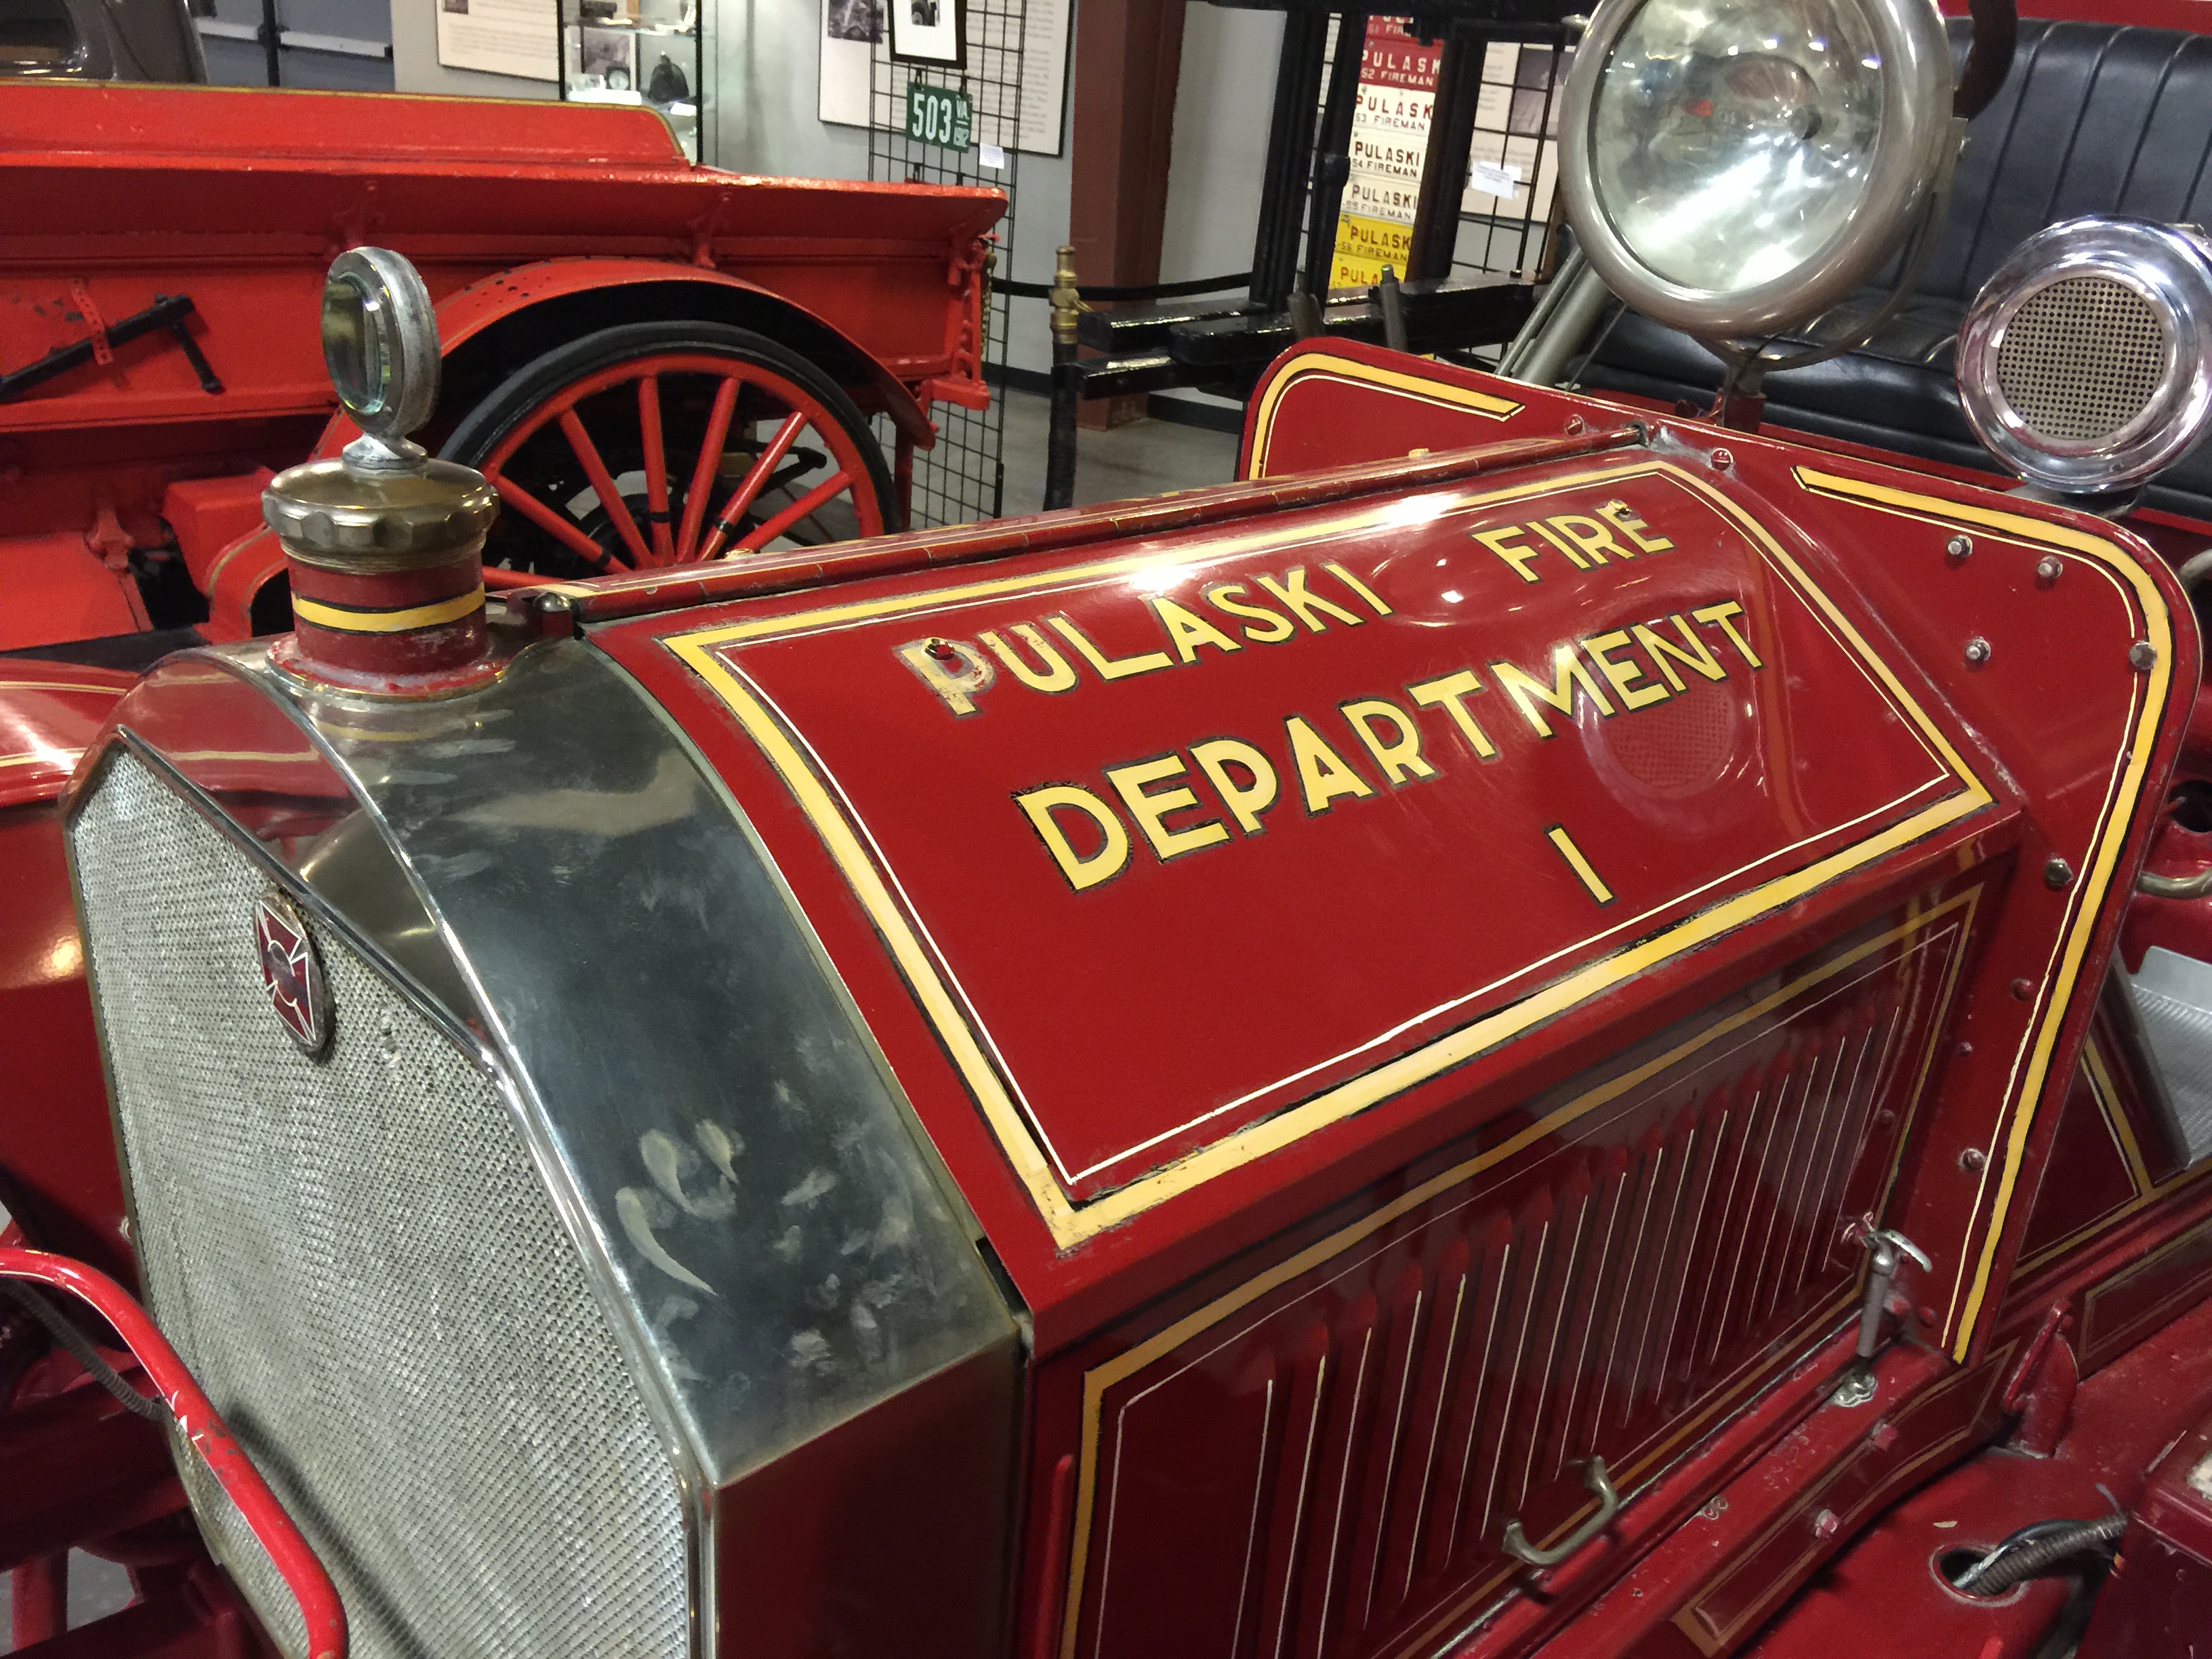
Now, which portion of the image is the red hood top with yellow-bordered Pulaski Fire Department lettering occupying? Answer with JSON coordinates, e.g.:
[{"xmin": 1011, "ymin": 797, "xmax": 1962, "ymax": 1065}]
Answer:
[{"xmin": 593, "ymin": 407, "xmax": 2175, "ymax": 1353}]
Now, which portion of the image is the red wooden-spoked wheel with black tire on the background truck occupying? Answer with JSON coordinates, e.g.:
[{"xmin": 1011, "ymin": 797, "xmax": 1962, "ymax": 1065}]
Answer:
[{"xmin": 443, "ymin": 321, "xmax": 898, "ymax": 577}]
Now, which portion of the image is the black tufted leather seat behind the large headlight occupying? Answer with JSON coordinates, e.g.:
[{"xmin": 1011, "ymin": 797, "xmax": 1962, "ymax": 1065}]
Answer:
[{"xmin": 1582, "ymin": 18, "xmax": 2212, "ymax": 518}]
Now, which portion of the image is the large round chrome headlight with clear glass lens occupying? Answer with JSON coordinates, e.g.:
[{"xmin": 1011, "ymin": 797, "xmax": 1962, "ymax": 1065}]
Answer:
[{"xmin": 1559, "ymin": 0, "xmax": 1951, "ymax": 338}]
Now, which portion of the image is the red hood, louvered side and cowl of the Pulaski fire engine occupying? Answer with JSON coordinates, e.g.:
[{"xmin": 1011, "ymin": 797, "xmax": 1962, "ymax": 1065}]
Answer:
[{"xmin": 579, "ymin": 345, "xmax": 2203, "ymax": 1659}]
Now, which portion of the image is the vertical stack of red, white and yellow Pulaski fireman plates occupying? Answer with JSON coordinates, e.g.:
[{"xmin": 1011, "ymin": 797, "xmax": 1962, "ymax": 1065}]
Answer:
[{"xmin": 1330, "ymin": 18, "xmax": 1442, "ymax": 287}]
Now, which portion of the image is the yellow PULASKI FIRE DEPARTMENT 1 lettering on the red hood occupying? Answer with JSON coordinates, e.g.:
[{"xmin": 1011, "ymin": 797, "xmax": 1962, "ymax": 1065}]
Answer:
[{"xmin": 896, "ymin": 502, "xmax": 1765, "ymax": 905}]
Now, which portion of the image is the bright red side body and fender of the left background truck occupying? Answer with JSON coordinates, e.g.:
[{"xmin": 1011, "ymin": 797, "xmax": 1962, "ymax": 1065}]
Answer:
[{"xmin": 0, "ymin": 80, "xmax": 1004, "ymax": 646}]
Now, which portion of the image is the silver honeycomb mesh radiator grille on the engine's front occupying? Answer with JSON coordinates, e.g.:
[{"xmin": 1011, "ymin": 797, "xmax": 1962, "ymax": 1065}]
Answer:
[{"xmin": 70, "ymin": 754, "xmax": 690, "ymax": 1659}]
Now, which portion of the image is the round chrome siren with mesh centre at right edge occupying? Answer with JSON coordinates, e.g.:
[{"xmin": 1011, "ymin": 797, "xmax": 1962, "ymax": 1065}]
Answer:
[{"xmin": 1958, "ymin": 219, "xmax": 2212, "ymax": 493}]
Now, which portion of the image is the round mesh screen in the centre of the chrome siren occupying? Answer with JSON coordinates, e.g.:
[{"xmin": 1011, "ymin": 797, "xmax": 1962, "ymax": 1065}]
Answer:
[{"xmin": 1997, "ymin": 276, "xmax": 2165, "ymax": 443}]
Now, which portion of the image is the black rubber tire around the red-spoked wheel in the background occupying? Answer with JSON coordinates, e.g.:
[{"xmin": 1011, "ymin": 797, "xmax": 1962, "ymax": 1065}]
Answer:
[{"xmin": 438, "ymin": 319, "xmax": 900, "ymax": 579}]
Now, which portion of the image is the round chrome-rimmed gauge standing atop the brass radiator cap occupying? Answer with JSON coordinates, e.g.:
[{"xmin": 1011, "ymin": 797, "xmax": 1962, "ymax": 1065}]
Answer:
[{"xmin": 323, "ymin": 248, "xmax": 438, "ymax": 445}]
